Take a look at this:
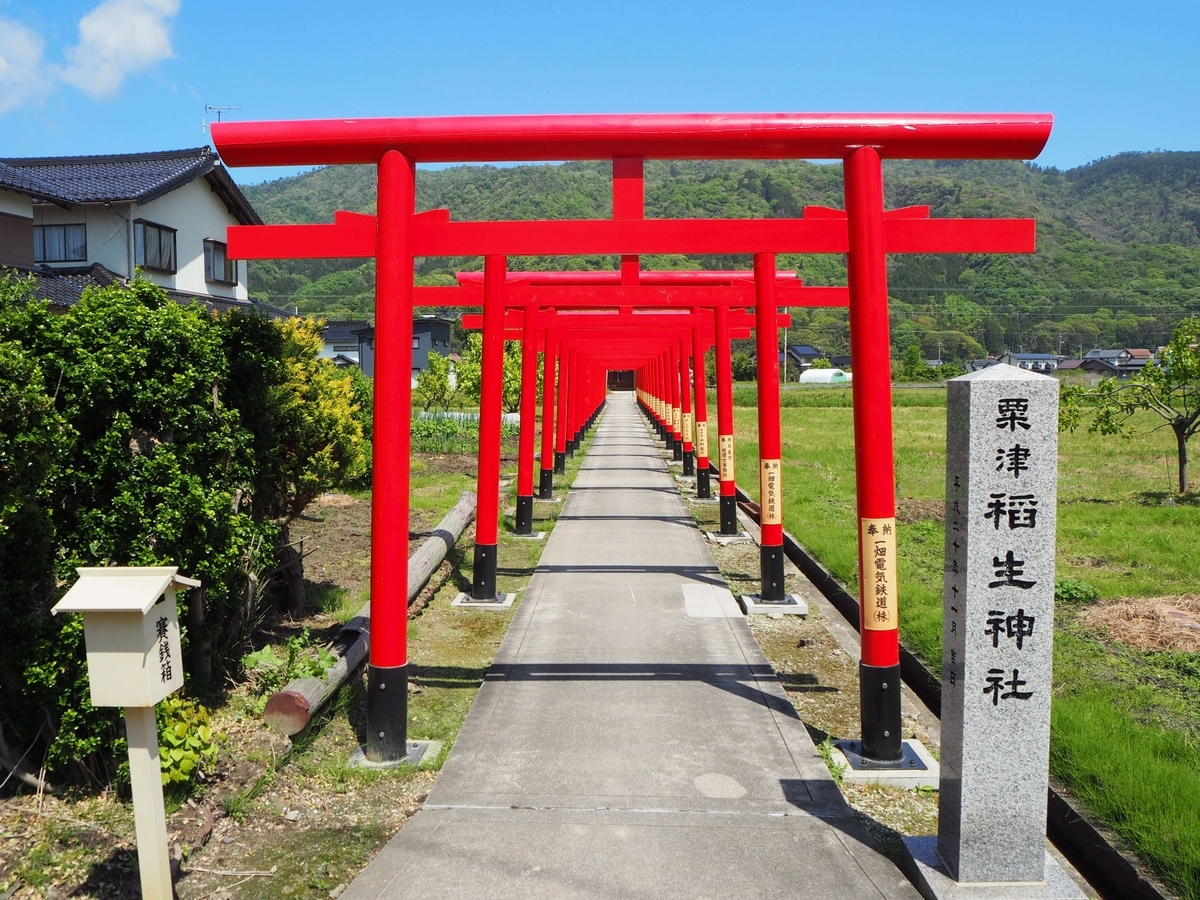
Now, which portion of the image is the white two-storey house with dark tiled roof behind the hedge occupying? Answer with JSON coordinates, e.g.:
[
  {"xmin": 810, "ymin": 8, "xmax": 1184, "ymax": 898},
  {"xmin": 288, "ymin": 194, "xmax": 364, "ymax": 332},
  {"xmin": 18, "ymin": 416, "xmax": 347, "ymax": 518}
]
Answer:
[{"xmin": 0, "ymin": 146, "xmax": 272, "ymax": 312}]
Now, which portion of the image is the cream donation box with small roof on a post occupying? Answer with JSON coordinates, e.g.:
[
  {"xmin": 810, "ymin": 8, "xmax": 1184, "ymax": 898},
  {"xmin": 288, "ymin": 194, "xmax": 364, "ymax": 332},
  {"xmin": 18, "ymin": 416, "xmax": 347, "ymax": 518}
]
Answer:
[{"xmin": 52, "ymin": 565, "xmax": 200, "ymax": 900}]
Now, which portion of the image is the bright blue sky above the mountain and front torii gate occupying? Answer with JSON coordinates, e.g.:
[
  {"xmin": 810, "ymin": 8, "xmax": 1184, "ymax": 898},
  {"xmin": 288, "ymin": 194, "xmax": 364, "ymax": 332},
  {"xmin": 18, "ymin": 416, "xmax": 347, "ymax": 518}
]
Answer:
[{"xmin": 0, "ymin": 0, "xmax": 1200, "ymax": 182}]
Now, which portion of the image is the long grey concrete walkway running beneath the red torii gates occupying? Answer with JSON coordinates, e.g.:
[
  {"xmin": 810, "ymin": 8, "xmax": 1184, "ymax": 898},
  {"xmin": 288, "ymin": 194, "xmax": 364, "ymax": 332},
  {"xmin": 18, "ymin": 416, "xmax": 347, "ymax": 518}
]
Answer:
[{"xmin": 343, "ymin": 394, "xmax": 917, "ymax": 900}]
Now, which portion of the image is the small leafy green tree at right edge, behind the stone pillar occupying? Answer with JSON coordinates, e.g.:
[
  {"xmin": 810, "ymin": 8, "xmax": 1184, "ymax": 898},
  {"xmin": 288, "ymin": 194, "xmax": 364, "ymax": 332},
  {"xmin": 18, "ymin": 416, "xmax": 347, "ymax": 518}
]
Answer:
[{"xmin": 1058, "ymin": 318, "xmax": 1200, "ymax": 493}]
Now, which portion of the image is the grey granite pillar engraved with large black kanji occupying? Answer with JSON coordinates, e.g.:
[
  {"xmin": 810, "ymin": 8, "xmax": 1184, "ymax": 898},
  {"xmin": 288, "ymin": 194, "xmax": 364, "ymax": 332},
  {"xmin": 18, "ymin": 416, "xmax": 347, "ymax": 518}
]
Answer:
[{"xmin": 937, "ymin": 365, "xmax": 1058, "ymax": 884}]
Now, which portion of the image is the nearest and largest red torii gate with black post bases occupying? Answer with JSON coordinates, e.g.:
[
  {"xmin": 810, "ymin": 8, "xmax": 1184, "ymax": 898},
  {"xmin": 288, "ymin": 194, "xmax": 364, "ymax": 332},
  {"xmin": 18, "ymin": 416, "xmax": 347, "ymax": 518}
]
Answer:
[{"xmin": 212, "ymin": 113, "xmax": 1052, "ymax": 761}]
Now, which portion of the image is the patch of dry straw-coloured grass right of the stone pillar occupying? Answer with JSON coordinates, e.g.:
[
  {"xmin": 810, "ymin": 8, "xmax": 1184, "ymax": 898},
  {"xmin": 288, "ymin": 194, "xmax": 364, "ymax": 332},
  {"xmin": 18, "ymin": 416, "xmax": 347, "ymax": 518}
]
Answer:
[{"xmin": 1079, "ymin": 594, "xmax": 1200, "ymax": 653}]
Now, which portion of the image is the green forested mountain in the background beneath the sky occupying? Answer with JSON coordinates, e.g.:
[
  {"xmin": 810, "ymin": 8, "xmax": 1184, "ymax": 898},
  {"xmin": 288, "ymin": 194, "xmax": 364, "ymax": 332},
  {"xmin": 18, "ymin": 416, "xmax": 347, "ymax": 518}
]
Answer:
[{"xmin": 238, "ymin": 152, "xmax": 1200, "ymax": 359}]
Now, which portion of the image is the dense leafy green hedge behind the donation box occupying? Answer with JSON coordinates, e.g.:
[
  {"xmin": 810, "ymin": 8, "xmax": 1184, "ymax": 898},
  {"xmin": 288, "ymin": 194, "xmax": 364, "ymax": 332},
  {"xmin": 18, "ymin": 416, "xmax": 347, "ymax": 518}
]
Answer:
[{"xmin": 0, "ymin": 278, "xmax": 362, "ymax": 785}]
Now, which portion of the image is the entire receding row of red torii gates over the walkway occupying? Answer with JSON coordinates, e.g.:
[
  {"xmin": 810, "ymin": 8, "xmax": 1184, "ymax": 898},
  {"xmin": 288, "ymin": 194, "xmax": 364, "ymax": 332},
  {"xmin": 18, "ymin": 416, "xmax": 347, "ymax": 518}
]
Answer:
[{"xmin": 211, "ymin": 113, "xmax": 1054, "ymax": 762}]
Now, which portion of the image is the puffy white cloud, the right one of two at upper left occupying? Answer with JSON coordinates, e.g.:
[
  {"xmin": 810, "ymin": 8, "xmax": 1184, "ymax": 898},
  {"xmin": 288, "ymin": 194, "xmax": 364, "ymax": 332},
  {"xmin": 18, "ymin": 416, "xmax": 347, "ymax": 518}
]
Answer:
[{"xmin": 62, "ymin": 0, "xmax": 180, "ymax": 98}]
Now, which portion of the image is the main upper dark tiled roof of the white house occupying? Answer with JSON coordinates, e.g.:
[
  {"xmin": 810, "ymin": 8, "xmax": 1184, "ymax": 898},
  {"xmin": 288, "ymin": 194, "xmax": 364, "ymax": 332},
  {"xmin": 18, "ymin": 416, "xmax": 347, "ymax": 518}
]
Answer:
[{"xmin": 0, "ymin": 146, "xmax": 262, "ymax": 224}]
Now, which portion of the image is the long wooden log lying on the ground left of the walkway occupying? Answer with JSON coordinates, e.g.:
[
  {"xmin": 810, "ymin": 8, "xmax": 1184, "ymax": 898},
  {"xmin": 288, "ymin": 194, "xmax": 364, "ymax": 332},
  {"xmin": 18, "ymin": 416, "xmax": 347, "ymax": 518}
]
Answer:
[{"xmin": 263, "ymin": 491, "xmax": 475, "ymax": 734}]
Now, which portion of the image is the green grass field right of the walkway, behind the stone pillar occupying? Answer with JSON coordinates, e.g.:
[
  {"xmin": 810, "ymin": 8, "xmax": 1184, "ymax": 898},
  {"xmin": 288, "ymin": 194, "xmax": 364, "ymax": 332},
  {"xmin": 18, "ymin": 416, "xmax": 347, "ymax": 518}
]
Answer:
[{"xmin": 734, "ymin": 386, "xmax": 1200, "ymax": 900}]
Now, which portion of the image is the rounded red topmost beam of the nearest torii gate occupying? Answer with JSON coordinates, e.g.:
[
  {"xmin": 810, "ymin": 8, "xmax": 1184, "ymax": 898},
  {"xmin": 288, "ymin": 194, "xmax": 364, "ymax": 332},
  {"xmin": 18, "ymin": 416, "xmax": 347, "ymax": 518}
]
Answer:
[{"xmin": 210, "ymin": 113, "xmax": 1054, "ymax": 166}]
